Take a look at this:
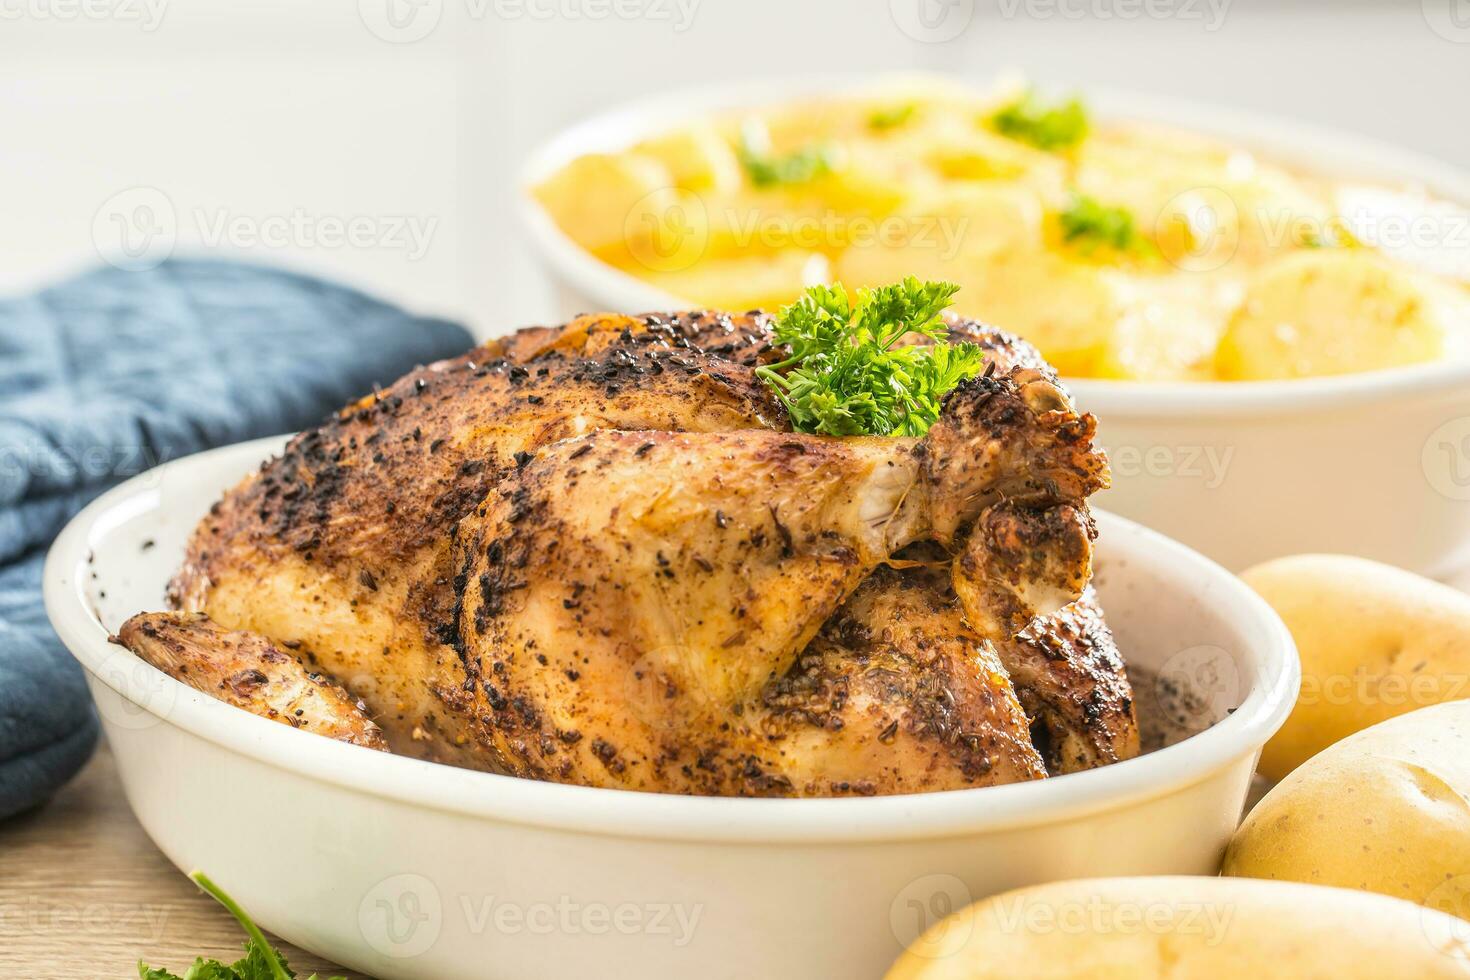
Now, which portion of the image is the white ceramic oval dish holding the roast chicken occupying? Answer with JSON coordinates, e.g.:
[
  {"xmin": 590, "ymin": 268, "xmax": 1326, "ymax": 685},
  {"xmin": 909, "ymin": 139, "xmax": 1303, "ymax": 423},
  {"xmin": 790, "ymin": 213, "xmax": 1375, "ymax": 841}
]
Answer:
[{"xmin": 46, "ymin": 439, "xmax": 1299, "ymax": 980}]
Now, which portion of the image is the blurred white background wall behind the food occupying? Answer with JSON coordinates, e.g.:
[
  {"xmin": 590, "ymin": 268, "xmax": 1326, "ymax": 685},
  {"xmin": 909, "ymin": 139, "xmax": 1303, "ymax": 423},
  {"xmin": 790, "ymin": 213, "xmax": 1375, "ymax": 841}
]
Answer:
[{"xmin": 0, "ymin": 0, "xmax": 1470, "ymax": 334}]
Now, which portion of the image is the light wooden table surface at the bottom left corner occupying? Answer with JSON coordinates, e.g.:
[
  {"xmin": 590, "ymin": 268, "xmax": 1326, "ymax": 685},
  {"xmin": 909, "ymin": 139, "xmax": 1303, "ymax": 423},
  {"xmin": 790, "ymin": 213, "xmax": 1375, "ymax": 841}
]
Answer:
[{"xmin": 0, "ymin": 742, "xmax": 362, "ymax": 980}]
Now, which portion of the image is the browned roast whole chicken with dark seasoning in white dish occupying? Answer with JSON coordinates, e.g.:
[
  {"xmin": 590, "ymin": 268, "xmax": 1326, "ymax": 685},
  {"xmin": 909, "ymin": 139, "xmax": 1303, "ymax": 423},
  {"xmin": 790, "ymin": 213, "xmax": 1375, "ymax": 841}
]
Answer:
[{"xmin": 116, "ymin": 311, "xmax": 1138, "ymax": 796}]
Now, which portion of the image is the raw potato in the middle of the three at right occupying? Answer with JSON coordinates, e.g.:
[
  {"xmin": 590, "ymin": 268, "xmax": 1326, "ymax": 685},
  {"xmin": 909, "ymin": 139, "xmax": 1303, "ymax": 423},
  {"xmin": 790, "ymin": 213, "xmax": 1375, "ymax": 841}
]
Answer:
[{"xmin": 1225, "ymin": 701, "xmax": 1470, "ymax": 916}]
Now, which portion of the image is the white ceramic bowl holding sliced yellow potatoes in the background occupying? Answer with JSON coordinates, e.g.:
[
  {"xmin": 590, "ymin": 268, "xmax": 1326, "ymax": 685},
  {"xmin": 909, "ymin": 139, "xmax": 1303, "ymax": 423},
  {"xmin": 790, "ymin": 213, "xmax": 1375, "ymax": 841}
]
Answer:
[{"xmin": 520, "ymin": 79, "xmax": 1470, "ymax": 576}]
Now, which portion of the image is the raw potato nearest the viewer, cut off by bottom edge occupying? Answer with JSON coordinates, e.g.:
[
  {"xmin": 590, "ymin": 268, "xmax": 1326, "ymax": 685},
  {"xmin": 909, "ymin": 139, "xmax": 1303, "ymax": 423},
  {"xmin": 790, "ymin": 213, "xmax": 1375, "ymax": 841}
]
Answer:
[{"xmin": 888, "ymin": 877, "xmax": 1470, "ymax": 980}]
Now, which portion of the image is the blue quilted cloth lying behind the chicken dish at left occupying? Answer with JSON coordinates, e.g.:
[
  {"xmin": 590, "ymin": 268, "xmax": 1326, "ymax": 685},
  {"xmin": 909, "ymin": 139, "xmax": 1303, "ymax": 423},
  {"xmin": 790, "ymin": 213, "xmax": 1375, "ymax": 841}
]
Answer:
[{"xmin": 0, "ymin": 260, "xmax": 470, "ymax": 818}]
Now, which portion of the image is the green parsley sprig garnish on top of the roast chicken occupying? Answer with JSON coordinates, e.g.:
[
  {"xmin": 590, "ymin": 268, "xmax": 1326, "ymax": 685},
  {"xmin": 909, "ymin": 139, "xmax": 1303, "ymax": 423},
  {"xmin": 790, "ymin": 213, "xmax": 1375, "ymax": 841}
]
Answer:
[{"xmin": 756, "ymin": 276, "xmax": 985, "ymax": 436}]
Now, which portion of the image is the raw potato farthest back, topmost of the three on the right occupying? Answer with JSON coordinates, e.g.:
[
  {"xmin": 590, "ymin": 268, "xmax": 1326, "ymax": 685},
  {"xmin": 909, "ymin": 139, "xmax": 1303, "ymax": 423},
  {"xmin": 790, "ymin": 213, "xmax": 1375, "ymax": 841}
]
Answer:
[{"xmin": 1241, "ymin": 555, "xmax": 1470, "ymax": 787}]
